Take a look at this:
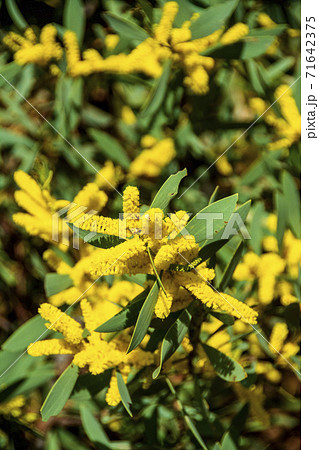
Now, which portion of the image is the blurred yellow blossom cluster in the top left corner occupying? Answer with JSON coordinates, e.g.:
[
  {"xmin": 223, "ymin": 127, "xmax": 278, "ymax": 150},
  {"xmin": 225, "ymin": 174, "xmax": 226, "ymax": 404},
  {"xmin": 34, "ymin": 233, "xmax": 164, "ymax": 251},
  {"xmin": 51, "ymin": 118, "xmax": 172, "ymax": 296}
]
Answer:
[{"xmin": 3, "ymin": 24, "xmax": 63, "ymax": 66}]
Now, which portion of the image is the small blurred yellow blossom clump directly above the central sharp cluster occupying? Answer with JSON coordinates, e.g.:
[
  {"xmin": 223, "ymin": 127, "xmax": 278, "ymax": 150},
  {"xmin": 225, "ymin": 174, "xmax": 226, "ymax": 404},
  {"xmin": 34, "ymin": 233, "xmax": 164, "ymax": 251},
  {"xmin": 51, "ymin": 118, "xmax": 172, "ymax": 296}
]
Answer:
[{"xmin": 130, "ymin": 135, "xmax": 176, "ymax": 178}]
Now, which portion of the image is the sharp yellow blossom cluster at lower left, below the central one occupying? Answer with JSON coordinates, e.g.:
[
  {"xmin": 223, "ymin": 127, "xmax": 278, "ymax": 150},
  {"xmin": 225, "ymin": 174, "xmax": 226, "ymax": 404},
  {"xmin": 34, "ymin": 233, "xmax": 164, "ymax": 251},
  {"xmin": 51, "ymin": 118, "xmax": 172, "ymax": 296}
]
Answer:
[{"xmin": 28, "ymin": 299, "xmax": 154, "ymax": 406}]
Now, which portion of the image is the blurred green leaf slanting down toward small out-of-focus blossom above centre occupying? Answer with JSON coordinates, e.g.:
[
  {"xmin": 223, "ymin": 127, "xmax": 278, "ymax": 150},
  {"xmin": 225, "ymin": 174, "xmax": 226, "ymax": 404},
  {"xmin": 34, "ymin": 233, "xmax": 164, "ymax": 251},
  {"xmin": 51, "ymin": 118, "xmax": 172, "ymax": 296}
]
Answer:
[{"xmin": 88, "ymin": 128, "xmax": 130, "ymax": 169}]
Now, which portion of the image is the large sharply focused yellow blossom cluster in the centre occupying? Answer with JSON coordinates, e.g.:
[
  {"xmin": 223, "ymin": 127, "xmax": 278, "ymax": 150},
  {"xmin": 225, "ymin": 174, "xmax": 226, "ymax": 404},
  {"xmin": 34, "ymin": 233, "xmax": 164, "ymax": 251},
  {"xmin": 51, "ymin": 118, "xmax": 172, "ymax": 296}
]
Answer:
[{"xmin": 76, "ymin": 186, "xmax": 257, "ymax": 323}]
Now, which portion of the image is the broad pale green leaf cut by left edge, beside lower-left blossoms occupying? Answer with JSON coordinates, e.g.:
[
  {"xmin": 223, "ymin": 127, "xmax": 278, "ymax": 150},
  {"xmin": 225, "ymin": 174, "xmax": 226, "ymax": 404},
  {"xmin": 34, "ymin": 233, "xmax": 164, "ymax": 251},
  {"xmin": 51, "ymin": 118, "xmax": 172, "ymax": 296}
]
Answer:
[{"xmin": 2, "ymin": 314, "xmax": 48, "ymax": 352}]
